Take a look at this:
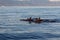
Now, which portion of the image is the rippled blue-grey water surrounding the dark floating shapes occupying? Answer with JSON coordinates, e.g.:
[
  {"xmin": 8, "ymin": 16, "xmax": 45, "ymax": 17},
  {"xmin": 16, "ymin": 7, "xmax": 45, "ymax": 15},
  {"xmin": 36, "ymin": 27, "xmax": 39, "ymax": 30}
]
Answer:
[{"xmin": 0, "ymin": 7, "xmax": 60, "ymax": 40}]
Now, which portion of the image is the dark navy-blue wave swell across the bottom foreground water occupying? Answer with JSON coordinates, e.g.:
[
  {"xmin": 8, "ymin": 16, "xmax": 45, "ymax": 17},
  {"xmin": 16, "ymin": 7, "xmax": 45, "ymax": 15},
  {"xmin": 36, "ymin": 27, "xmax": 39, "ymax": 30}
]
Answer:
[{"xmin": 0, "ymin": 32, "xmax": 60, "ymax": 40}]
